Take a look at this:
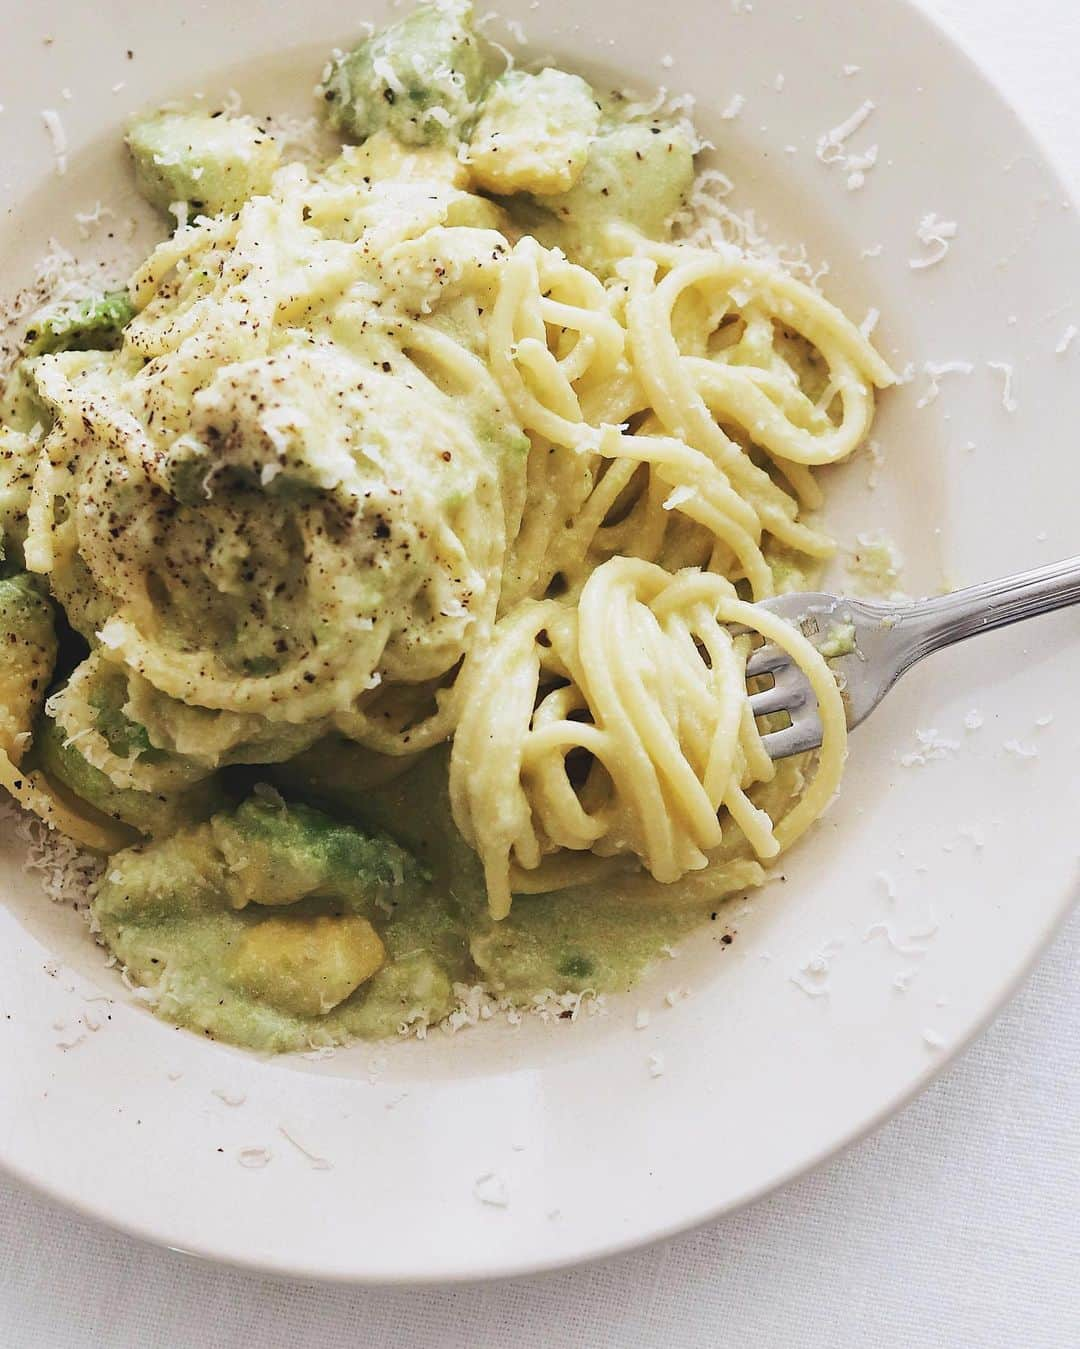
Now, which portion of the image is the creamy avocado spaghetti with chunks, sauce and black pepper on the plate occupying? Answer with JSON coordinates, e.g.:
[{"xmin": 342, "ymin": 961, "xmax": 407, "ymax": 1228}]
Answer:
[{"xmin": 0, "ymin": 0, "xmax": 894, "ymax": 1051}]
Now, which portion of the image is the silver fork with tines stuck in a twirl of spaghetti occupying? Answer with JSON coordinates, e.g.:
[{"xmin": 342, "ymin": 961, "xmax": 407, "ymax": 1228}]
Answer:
[{"xmin": 746, "ymin": 557, "xmax": 1080, "ymax": 759}]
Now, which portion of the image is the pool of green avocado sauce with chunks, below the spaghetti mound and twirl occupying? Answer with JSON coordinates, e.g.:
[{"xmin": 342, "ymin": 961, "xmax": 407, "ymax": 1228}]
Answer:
[{"xmin": 93, "ymin": 751, "xmax": 698, "ymax": 1050}]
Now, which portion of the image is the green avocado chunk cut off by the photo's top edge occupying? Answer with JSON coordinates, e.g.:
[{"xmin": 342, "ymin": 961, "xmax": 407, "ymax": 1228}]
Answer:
[{"xmin": 322, "ymin": 0, "xmax": 487, "ymax": 146}]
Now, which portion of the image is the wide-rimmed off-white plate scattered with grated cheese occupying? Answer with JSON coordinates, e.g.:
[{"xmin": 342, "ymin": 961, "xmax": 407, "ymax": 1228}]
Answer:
[{"xmin": 0, "ymin": 0, "xmax": 1080, "ymax": 1282}]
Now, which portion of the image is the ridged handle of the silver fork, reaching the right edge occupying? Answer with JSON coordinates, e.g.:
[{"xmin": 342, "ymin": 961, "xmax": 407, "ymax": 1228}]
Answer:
[{"xmin": 895, "ymin": 557, "xmax": 1080, "ymax": 669}]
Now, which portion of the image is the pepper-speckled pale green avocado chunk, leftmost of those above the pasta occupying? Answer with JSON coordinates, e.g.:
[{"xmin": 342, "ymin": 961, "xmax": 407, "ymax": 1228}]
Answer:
[{"xmin": 127, "ymin": 112, "xmax": 280, "ymax": 216}]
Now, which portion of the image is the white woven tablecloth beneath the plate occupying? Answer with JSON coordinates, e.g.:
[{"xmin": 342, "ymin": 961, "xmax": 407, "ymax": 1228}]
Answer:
[{"xmin": 0, "ymin": 0, "xmax": 1080, "ymax": 1349}]
